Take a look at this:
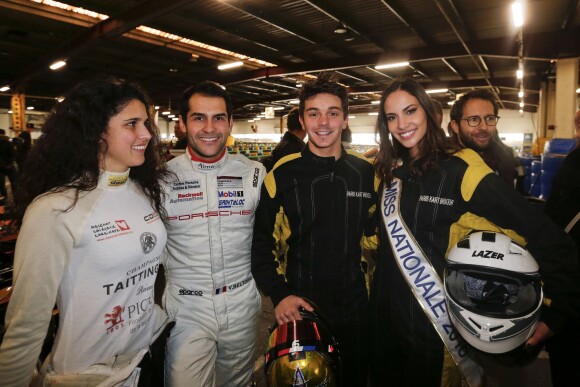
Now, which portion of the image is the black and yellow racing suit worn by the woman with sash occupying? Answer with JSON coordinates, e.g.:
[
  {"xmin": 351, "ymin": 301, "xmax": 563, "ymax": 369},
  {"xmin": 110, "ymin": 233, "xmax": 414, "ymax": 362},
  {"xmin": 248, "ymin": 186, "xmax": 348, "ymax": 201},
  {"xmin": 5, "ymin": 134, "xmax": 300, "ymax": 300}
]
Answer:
[{"xmin": 370, "ymin": 149, "xmax": 580, "ymax": 386}]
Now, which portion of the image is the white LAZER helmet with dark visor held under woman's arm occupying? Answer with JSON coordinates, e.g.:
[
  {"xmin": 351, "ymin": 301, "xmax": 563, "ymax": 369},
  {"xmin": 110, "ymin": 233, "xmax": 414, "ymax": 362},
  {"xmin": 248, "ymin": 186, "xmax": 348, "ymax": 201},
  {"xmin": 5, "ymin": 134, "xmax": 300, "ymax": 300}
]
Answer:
[{"xmin": 444, "ymin": 232, "xmax": 543, "ymax": 354}]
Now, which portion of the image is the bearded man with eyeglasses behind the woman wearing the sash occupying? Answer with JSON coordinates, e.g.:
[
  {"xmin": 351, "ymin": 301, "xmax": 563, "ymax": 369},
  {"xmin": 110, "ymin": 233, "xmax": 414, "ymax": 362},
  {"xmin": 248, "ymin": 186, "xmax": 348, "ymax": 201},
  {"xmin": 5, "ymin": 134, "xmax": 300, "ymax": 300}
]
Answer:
[{"xmin": 448, "ymin": 90, "xmax": 524, "ymax": 194}]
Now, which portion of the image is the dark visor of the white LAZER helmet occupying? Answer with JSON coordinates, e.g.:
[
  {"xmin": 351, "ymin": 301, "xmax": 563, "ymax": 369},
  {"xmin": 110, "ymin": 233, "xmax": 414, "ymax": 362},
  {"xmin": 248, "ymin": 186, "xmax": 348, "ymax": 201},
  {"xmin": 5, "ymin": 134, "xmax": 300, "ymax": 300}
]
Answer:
[{"xmin": 445, "ymin": 264, "xmax": 542, "ymax": 318}]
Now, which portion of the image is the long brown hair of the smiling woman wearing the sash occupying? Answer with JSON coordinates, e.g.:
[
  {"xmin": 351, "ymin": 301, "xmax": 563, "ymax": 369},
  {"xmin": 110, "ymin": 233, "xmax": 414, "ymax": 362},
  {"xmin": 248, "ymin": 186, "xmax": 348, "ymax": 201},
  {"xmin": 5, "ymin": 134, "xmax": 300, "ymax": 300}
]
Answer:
[{"xmin": 375, "ymin": 79, "xmax": 458, "ymax": 183}]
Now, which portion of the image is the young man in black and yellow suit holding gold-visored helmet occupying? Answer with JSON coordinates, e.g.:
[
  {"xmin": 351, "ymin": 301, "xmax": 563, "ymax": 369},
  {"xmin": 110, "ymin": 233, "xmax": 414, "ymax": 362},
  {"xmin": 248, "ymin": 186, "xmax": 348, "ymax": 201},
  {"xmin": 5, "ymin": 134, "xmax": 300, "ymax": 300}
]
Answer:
[{"xmin": 252, "ymin": 75, "xmax": 378, "ymax": 386}]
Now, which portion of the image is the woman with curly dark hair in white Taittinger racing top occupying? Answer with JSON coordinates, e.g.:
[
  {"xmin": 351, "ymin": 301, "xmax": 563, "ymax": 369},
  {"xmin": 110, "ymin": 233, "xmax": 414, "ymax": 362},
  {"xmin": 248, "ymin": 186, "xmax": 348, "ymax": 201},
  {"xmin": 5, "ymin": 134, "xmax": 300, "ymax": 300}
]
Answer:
[{"xmin": 0, "ymin": 78, "xmax": 171, "ymax": 386}]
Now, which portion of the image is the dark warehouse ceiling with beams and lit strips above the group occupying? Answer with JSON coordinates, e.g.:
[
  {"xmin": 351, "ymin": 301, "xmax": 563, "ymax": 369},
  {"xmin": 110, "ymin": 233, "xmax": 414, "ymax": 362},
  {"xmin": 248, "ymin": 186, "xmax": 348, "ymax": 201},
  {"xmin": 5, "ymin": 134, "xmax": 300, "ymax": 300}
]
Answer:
[{"xmin": 0, "ymin": 0, "xmax": 580, "ymax": 123}]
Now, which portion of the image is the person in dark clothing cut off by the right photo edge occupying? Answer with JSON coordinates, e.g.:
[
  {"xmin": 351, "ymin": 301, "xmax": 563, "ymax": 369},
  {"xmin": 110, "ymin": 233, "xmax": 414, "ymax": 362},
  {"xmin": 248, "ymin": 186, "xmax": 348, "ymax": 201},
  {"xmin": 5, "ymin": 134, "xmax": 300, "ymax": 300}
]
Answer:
[{"xmin": 544, "ymin": 110, "xmax": 580, "ymax": 387}]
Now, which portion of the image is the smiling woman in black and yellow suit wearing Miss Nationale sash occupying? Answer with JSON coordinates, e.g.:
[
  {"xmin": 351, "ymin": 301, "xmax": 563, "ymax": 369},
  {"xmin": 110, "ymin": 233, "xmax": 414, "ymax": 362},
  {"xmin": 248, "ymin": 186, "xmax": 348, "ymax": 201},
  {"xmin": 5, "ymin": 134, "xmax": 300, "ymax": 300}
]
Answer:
[{"xmin": 370, "ymin": 80, "xmax": 580, "ymax": 386}]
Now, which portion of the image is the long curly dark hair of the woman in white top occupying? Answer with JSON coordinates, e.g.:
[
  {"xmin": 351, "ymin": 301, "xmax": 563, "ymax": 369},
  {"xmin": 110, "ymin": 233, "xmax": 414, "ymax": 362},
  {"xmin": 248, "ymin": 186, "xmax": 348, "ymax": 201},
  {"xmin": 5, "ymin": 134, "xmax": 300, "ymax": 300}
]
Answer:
[{"xmin": 13, "ymin": 77, "xmax": 167, "ymax": 229}]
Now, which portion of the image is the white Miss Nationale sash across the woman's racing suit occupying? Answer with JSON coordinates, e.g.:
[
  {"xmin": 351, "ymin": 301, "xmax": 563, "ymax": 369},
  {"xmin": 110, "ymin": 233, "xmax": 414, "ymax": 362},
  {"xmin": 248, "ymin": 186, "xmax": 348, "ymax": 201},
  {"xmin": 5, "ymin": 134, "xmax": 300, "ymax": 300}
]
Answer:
[{"xmin": 381, "ymin": 178, "xmax": 482, "ymax": 387}]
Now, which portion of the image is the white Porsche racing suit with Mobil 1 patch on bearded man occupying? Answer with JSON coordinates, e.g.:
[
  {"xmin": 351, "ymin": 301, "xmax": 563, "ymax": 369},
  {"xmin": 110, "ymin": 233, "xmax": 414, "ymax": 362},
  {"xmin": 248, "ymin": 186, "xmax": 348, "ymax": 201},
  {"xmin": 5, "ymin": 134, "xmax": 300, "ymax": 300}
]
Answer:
[{"xmin": 164, "ymin": 152, "xmax": 265, "ymax": 387}]
